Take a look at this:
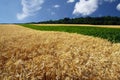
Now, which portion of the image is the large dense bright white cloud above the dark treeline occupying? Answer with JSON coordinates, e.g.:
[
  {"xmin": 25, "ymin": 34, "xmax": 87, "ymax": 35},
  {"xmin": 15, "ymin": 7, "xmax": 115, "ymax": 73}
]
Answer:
[{"xmin": 73, "ymin": 0, "xmax": 99, "ymax": 16}]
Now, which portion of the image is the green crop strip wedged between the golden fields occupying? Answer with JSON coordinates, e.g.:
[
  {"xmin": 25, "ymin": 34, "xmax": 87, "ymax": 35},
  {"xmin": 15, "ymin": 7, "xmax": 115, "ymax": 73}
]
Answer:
[{"xmin": 20, "ymin": 24, "xmax": 120, "ymax": 43}]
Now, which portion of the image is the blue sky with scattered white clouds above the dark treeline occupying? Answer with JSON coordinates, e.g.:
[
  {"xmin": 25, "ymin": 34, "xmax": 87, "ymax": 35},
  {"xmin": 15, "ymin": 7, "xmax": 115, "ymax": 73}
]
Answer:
[{"xmin": 0, "ymin": 0, "xmax": 120, "ymax": 23}]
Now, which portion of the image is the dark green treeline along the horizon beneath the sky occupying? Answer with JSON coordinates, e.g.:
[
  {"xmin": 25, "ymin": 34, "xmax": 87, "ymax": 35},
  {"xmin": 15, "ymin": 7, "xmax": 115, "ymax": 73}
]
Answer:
[{"xmin": 36, "ymin": 16, "xmax": 120, "ymax": 25}]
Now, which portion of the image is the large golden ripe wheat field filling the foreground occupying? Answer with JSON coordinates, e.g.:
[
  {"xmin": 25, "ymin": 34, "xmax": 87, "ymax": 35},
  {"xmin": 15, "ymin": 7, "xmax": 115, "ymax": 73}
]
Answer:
[{"xmin": 0, "ymin": 24, "xmax": 120, "ymax": 80}]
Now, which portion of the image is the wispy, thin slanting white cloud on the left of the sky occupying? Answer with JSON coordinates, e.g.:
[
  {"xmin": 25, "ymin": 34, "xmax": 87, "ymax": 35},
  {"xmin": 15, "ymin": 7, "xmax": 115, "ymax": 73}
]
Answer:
[{"xmin": 17, "ymin": 0, "xmax": 44, "ymax": 20}]
